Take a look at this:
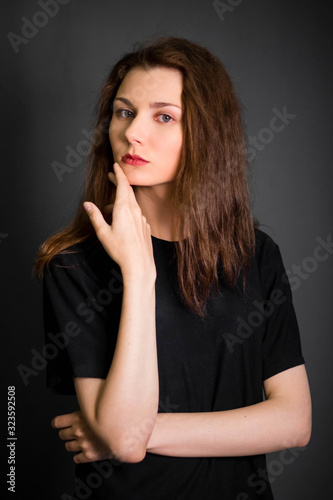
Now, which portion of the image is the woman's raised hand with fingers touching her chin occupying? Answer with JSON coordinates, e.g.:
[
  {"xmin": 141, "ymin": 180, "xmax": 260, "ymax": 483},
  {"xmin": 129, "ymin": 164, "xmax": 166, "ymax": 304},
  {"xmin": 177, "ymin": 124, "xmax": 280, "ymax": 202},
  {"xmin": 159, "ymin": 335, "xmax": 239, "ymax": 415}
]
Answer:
[{"xmin": 84, "ymin": 163, "xmax": 156, "ymax": 280}]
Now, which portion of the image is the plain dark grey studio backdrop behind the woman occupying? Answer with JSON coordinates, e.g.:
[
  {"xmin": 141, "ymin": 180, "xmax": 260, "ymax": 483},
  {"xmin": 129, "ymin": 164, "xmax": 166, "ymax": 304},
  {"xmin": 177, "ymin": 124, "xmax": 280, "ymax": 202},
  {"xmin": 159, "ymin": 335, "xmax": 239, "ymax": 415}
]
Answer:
[{"xmin": 0, "ymin": 0, "xmax": 333, "ymax": 500}]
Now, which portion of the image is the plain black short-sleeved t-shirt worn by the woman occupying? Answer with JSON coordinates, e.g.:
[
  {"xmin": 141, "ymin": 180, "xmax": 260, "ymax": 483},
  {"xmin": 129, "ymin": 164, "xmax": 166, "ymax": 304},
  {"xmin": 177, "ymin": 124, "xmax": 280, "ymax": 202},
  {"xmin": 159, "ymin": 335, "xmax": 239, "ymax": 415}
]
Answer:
[{"xmin": 44, "ymin": 230, "xmax": 304, "ymax": 500}]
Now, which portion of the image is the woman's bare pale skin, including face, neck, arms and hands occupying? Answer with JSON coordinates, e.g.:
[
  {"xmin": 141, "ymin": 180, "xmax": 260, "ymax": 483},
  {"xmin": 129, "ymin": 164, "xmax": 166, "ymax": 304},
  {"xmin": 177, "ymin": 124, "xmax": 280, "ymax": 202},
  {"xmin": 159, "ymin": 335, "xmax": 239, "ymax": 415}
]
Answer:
[{"xmin": 52, "ymin": 68, "xmax": 311, "ymax": 463}]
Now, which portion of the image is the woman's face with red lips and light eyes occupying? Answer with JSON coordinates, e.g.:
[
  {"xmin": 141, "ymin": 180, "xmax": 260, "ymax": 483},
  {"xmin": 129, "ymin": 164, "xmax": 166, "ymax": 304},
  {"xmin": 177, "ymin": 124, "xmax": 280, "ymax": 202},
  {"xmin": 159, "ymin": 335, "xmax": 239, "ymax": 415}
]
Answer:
[{"xmin": 109, "ymin": 67, "xmax": 183, "ymax": 186}]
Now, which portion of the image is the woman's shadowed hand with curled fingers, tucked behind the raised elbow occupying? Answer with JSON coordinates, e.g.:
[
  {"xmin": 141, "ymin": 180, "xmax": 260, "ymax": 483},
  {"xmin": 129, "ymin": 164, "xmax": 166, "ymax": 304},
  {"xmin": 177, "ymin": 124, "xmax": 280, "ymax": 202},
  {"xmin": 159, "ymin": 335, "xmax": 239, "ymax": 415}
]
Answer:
[{"xmin": 51, "ymin": 411, "xmax": 113, "ymax": 464}]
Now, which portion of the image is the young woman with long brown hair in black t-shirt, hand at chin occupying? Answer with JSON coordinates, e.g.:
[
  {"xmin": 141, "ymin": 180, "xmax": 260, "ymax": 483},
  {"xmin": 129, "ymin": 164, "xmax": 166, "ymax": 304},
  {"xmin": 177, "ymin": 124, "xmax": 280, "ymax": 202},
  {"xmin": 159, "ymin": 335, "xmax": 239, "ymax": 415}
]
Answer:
[{"xmin": 36, "ymin": 37, "xmax": 311, "ymax": 500}]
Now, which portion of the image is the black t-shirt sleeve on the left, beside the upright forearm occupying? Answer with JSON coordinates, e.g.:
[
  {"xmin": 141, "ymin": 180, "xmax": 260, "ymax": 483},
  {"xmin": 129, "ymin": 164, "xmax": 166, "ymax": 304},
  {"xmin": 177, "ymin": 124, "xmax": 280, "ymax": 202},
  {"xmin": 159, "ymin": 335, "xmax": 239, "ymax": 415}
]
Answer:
[{"xmin": 43, "ymin": 244, "xmax": 122, "ymax": 394}]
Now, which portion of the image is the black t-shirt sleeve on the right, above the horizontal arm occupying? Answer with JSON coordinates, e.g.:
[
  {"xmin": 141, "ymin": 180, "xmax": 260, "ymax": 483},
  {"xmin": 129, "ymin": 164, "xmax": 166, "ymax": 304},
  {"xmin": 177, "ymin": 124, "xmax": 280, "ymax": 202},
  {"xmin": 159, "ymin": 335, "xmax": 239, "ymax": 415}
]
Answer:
[{"xmin": 255, "ymin": 233, "xmax": 304, "ymax": 380}]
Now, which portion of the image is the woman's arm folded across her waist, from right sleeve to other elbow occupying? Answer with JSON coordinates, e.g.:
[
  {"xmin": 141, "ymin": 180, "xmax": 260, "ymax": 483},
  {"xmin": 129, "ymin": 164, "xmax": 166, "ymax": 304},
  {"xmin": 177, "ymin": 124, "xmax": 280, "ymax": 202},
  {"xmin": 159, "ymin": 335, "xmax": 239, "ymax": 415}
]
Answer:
[{"xmin": 147, "ymin": 365, "xmax": 311, "ymax": 457}]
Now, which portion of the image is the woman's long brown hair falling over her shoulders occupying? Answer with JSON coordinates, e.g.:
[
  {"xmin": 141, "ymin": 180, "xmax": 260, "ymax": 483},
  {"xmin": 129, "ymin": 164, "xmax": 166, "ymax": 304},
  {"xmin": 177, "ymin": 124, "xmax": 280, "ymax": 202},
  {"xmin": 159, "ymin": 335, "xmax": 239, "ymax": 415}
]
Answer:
[{"xmin": 34, "ymin": 37, "xmax": 255, "ymax": 316}]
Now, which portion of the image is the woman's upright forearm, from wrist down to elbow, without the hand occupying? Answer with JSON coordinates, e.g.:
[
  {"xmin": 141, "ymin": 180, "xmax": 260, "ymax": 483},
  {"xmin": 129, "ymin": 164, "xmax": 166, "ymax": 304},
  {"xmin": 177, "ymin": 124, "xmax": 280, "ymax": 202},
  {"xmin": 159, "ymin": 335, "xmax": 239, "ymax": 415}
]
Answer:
[{"xmin": 77, "ymin": 273, "xmax": 158, "ymax": 461}]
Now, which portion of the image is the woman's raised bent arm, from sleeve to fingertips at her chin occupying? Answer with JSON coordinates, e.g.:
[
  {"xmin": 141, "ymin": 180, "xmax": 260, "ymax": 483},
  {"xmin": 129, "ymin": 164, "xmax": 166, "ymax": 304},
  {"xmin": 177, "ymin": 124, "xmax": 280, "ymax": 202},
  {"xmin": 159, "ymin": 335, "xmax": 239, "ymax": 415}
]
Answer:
[{"xmin": 65, "ymin": 165, "xmax": 158, "ymax": 462}]
